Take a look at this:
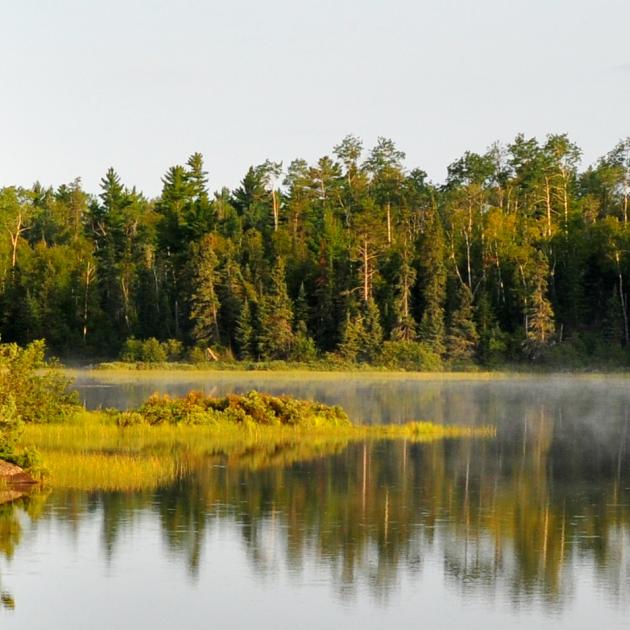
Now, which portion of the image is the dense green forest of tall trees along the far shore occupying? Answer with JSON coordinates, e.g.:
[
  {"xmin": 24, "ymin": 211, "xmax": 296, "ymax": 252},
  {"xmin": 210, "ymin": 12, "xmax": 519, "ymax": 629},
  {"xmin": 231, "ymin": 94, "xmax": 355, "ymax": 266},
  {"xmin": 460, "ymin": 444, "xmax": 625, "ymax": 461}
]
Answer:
[{"xmin": 0, "ymin": 135, "xmax": 630, "ymax": 367}]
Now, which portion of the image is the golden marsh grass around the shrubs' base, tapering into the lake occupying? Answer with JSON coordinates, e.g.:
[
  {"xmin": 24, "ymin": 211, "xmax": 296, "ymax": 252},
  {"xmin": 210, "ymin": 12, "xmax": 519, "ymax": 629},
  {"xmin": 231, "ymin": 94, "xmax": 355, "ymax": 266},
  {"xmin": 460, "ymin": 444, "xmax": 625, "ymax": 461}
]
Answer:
[{"xmin": 22, "ymin": 411, "xmax": 496, "ymax": 492}]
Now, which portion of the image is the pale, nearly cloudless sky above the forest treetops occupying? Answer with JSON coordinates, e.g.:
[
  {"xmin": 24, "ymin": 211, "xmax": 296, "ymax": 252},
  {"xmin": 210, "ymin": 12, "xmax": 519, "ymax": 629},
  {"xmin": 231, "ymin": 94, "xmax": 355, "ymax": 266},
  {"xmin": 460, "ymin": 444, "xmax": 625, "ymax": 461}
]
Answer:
[{"xmin": 0, "ymin": 0, "xmax": 630, "ymax": 196}]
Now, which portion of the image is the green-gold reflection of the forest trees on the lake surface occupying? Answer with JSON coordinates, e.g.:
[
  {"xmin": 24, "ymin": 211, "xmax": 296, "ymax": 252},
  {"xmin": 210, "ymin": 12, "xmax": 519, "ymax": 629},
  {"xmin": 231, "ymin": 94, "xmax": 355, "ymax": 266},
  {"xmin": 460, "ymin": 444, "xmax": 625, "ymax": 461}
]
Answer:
[{"xmin": 0, "ymin": 404, "xmax": 630, "ymax": 610}]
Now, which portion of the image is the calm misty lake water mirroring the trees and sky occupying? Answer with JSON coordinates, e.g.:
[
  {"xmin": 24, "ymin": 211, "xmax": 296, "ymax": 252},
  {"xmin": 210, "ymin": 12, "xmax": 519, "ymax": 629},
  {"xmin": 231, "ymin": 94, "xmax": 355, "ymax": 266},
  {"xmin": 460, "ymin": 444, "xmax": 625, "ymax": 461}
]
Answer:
[{"xmin": 0, "ymin": 373, "xmax": 630, "ymax": 630}]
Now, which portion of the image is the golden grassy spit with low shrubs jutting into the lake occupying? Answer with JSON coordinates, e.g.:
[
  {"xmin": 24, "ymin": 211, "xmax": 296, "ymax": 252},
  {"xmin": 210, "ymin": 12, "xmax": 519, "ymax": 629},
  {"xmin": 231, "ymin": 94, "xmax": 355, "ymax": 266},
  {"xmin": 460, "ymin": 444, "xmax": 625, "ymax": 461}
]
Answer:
[{"xmin": 22, "ymin": 392, "xmax": 495, "ymax": 492}]
